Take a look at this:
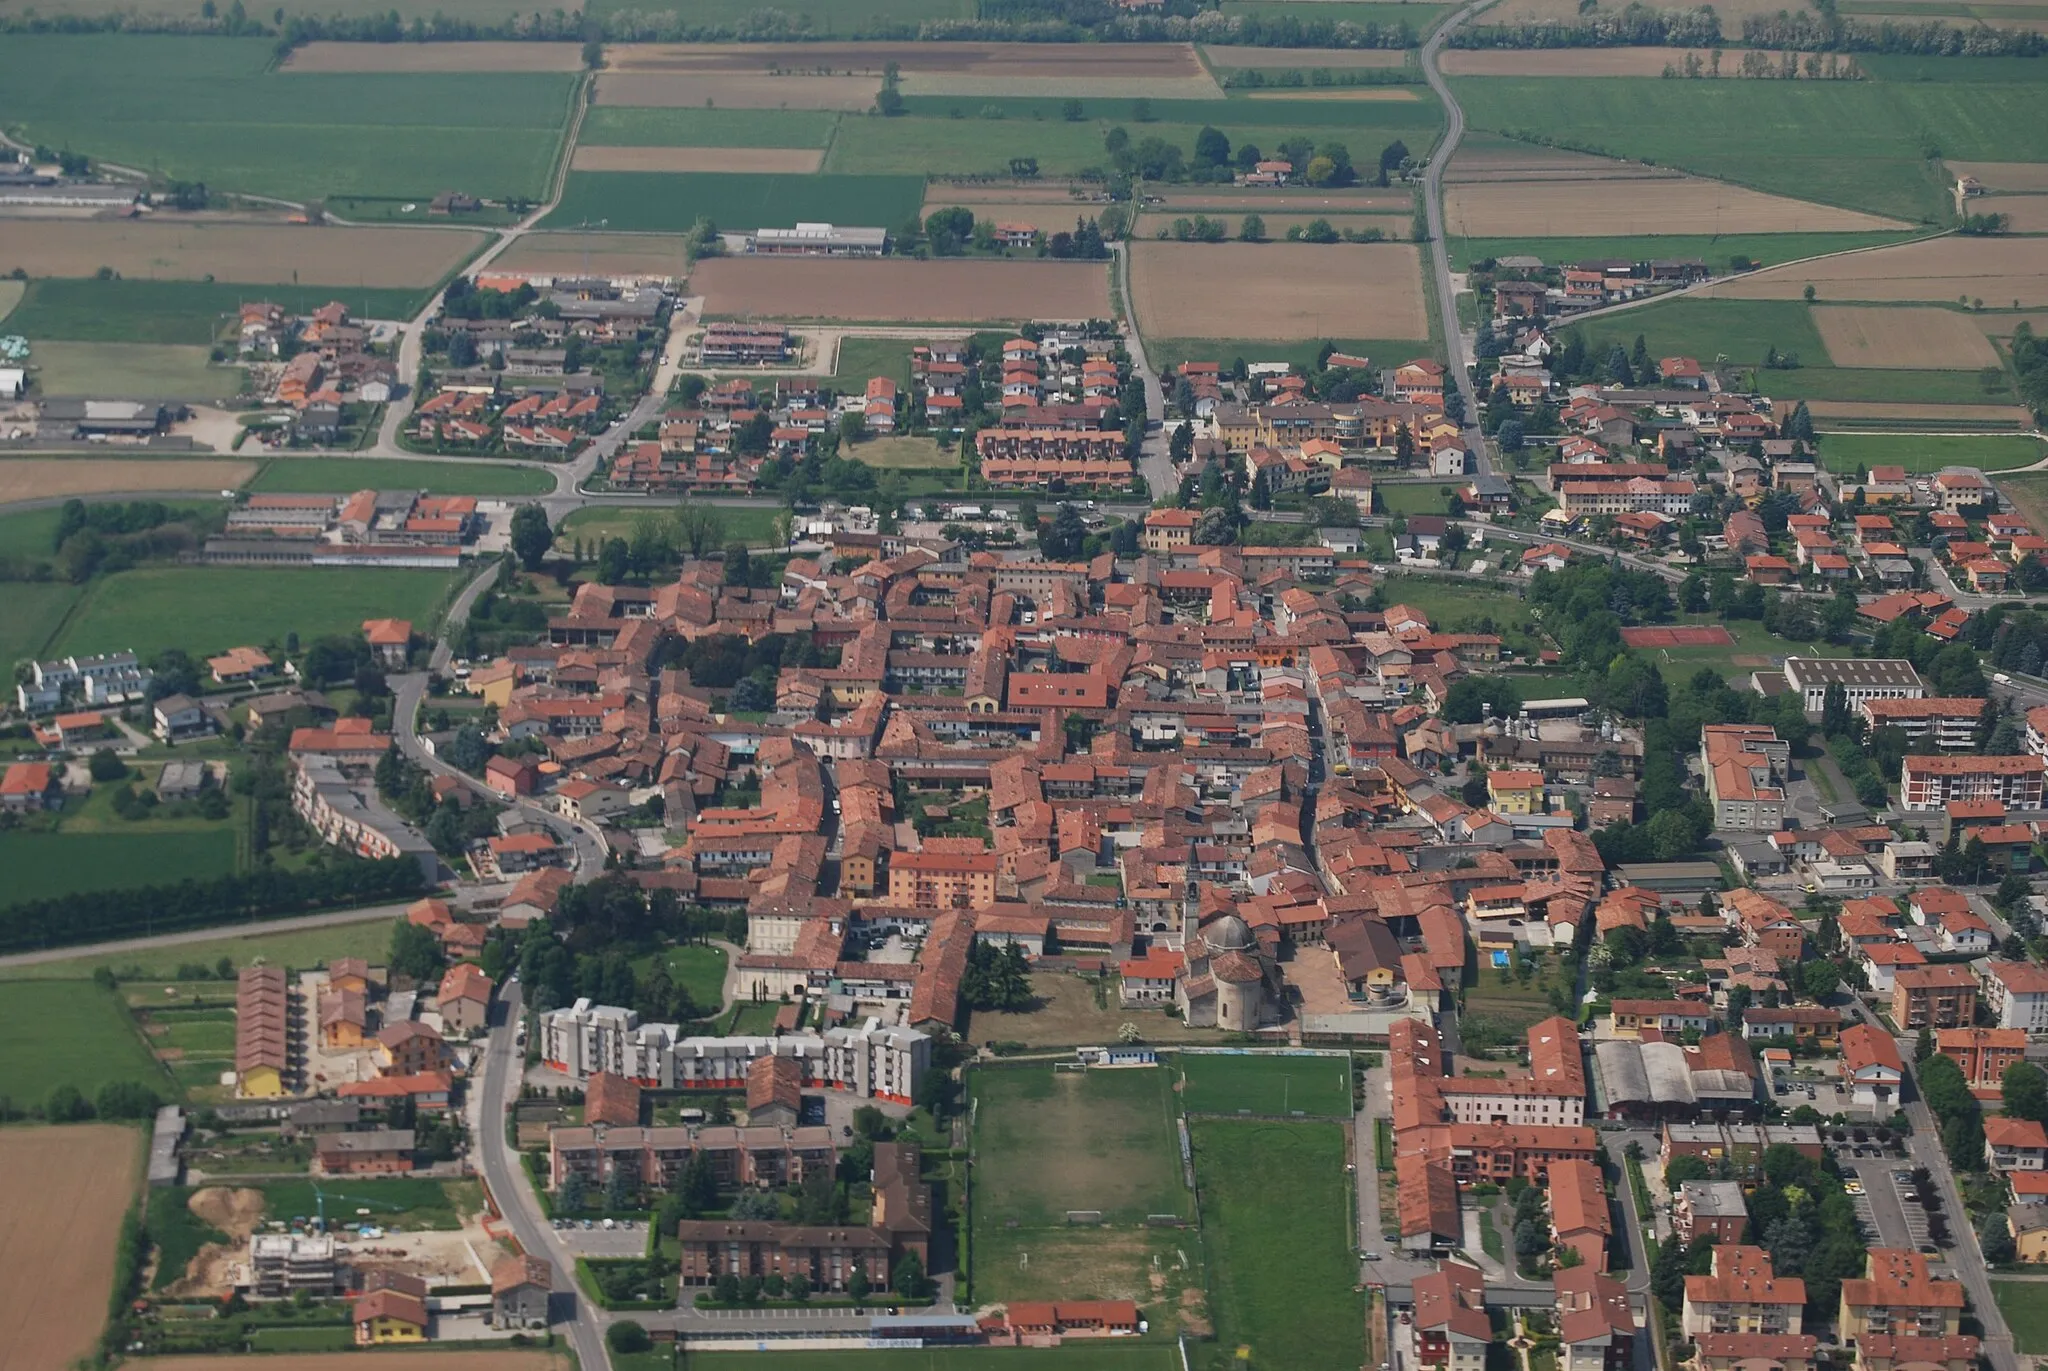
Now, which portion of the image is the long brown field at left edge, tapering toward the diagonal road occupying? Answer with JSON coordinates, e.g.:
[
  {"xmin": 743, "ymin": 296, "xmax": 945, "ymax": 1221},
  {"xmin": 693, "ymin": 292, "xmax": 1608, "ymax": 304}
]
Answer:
[{"xmin": 0, "ymin": 219, "xmax": 485, "ymax": 289}]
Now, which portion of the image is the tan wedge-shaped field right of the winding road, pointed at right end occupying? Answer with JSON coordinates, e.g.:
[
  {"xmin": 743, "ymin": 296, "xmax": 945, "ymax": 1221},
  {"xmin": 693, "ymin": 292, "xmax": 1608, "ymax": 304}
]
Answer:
[{"xmin": 1444, "ymin": 176, "xmax": 1907, "ymax": 238}]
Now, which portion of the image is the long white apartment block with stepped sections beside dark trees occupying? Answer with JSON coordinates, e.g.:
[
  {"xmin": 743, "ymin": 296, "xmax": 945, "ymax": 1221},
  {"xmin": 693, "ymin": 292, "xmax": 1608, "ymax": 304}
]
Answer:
[{"xmin": 541, "ymin": 1000, "xmax": 932, "ymax": 1105}]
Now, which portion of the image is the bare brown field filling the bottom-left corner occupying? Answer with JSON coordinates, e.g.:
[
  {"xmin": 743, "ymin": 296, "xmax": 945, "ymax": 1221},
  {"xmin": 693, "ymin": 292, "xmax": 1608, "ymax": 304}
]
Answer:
[{"xmin": 0, "ymin": 1123, "xmax": 141, "ymax": 1371}]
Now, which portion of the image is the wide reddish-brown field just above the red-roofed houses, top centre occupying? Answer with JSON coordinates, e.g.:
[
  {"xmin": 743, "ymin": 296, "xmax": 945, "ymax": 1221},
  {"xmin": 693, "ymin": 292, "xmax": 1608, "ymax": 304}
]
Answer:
[{"xmin": 690, "ymin": 258, "xmax": 1110, "ymax": 324}]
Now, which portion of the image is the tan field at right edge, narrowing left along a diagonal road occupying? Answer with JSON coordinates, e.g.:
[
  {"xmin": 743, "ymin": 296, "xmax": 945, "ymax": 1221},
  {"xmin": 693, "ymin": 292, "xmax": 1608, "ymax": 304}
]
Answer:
[{"xmin": 1702, "ymin": 238, "xmax": 2048, "ymax": 309}]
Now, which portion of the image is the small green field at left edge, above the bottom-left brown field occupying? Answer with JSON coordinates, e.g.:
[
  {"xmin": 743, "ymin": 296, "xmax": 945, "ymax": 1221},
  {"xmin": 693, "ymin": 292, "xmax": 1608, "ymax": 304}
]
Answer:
[{"xmin": 0, "ymin": 982, "xmax": 170, "ymax": 1109}]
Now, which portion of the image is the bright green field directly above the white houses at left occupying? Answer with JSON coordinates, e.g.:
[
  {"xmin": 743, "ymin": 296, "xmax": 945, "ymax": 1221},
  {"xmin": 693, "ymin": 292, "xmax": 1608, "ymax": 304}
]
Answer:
[{"xmin": 51, "ymin": 566, "xmax": 457, "ymax": 658}]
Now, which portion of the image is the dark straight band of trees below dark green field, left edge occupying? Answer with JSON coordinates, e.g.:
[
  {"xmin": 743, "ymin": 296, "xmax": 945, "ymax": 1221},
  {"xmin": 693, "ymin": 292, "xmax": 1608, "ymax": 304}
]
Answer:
[{"xmin": 0, "ymin": 855, "xmax": 426, "ymax": 953}]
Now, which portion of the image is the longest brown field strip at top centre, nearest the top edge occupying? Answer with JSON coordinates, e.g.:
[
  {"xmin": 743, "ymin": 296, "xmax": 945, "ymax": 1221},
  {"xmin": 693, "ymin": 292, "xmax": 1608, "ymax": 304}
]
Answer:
[{"xmin": 604, "ymin": 43, "xmax": 1204, "ymax": 80}]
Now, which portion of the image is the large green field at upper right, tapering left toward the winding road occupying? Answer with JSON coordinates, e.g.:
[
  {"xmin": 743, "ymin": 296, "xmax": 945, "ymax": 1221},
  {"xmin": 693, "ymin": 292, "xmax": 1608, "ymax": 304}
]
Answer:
[{"xmin": 1454, "ymin": 74, "xmax": 2048, "ymax": 223}]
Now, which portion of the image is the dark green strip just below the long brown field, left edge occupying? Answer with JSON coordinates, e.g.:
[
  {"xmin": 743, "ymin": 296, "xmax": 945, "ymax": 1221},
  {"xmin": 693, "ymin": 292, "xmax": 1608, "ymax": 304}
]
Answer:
[{"xmin": 0, "ymin": 278, "xmax": 428, "ymax": 348}]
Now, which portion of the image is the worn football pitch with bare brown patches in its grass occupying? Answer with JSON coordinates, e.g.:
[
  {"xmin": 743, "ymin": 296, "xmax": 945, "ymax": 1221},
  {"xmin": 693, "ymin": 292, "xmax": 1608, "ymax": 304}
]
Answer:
[{"xmin": 971, "ymin": 1066, "xmax": 1194, "ymax": 1303}]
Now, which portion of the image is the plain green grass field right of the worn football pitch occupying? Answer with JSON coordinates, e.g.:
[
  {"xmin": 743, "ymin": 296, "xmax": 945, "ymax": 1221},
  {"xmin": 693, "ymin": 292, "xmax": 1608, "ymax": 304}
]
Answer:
[{"xmin": 1190, "ymin": 1121, "xmax": 1366, "ymax": 1371}]
